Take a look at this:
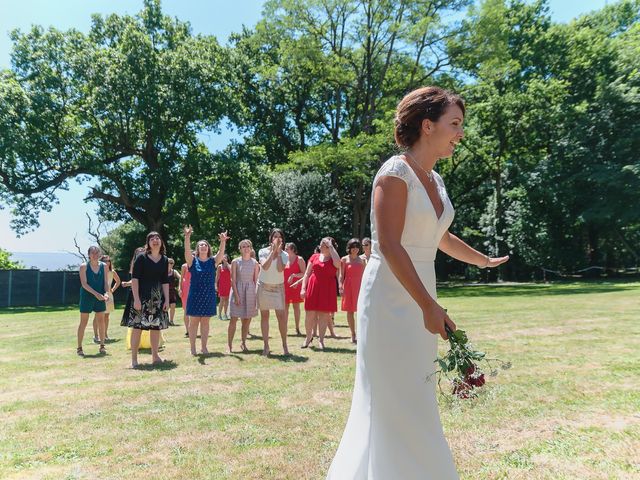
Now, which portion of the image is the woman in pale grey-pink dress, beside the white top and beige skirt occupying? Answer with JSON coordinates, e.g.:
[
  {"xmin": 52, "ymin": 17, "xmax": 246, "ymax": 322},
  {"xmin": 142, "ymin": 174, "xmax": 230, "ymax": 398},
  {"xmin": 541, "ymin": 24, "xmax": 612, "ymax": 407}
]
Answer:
[{"xmin": 227, "ymin": 239, "xmax": 260, "ymax": 353}]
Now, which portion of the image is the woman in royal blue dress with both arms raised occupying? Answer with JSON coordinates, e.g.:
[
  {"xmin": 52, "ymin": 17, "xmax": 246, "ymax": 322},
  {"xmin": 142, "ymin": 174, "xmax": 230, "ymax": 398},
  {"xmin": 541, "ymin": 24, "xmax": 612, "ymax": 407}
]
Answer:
[{"xmin": 184, "ymin": 225, "xmax": 229, "ymax": 355}]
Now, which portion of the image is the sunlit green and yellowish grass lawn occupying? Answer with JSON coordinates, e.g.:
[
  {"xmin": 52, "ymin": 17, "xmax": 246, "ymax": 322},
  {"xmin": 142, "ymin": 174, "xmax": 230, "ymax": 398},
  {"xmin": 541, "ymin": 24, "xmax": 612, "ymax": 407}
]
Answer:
[{"xmin": 0, "ymin": 283, "xmax": 640, "ymax": 480}]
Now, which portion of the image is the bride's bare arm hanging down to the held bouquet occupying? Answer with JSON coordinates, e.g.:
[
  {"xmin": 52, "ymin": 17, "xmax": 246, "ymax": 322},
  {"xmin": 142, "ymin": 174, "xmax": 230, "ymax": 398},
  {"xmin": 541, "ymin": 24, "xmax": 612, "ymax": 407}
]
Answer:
[{"xmin": 373, "ymin": 176, "xmax": 455, "ymax": 338}]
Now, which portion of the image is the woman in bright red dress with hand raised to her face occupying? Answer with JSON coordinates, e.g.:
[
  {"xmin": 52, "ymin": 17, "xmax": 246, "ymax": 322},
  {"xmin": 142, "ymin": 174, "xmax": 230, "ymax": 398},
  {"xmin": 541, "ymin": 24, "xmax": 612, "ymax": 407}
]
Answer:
[{"xmin": 300, "ymin": 237, "xmax": 340, "ymax": 350}]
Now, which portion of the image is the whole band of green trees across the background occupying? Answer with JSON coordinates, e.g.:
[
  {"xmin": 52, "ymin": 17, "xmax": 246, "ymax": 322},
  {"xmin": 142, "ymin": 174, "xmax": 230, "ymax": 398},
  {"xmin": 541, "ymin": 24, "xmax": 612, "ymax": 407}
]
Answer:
[{"xmin": 0, "ymin": 0, "xmax": 640, "ymax": 279}]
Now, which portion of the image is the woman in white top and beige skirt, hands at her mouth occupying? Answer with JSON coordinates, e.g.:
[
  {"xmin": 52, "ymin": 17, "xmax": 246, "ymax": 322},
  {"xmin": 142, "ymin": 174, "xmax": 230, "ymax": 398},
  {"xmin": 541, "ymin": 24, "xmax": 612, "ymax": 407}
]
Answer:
[{"xmin": 257, "ymin": 228, "xmax": 289, "ymax": 356}]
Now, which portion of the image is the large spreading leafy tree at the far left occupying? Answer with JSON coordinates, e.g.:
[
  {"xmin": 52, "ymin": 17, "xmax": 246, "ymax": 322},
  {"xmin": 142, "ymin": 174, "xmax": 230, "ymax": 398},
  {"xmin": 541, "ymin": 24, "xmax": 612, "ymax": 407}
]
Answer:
[{"xmin": 0, "ymin": 0, "xmax": 228, "ymax": 236}]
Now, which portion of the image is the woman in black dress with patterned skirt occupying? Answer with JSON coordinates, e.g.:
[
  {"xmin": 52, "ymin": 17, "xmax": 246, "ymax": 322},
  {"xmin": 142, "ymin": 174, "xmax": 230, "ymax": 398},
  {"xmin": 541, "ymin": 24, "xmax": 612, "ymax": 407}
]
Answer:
[{"xmin": 122, "ymin": 232, "xmax": 169, "ymax": 368}]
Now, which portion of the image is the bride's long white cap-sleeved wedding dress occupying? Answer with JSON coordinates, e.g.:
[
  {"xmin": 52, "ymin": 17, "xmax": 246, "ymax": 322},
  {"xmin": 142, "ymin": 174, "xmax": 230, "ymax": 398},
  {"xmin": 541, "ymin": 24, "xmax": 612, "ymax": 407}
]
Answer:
[{"xmin": 327, "ymin": 156, "xmax": 458, "ymax": 480}]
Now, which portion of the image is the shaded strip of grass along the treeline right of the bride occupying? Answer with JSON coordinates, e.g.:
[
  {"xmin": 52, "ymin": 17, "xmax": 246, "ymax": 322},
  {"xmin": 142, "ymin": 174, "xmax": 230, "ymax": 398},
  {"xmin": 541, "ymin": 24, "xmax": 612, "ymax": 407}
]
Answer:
[{"xmin": 438, "ymin": 282, "xmax": 638, "ymax": 298}]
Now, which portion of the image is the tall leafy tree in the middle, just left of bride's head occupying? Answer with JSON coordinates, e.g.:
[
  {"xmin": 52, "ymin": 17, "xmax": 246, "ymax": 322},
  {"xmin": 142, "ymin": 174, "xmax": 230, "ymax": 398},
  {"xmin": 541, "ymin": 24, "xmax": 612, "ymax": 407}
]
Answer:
[{"xmin": 228, "ymin": 0, "xmax": 469, "ymax": 236}]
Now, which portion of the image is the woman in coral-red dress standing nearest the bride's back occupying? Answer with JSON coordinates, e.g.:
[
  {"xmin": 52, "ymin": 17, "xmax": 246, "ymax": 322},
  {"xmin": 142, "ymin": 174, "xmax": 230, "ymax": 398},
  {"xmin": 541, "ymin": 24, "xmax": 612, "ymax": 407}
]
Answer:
[{"xmin": 339, "ymin": 238, "xmax": 365, "ymax": 343}]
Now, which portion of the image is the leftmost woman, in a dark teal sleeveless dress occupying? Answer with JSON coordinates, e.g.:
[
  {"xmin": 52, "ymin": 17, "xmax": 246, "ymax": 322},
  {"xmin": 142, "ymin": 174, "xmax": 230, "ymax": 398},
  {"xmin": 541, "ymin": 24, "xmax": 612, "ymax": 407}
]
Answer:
[{"xmin": 76, "ymin": 245, "xmax": 109, "ymax": 357}]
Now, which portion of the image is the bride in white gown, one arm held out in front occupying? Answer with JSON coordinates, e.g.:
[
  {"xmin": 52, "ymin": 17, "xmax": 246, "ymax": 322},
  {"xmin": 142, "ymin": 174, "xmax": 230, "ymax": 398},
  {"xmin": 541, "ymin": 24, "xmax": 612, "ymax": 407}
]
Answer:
[{"xmin": 327, "ymin": 87, "xmax": 509, "ymax": 480}]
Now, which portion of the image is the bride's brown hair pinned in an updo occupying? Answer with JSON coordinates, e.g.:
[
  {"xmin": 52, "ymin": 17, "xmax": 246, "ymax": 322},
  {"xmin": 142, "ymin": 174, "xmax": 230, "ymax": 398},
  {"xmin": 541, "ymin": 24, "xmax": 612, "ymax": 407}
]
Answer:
[{"xmin": 394, "ymin": 87, "xmax": 465, "ymax": 149}]
